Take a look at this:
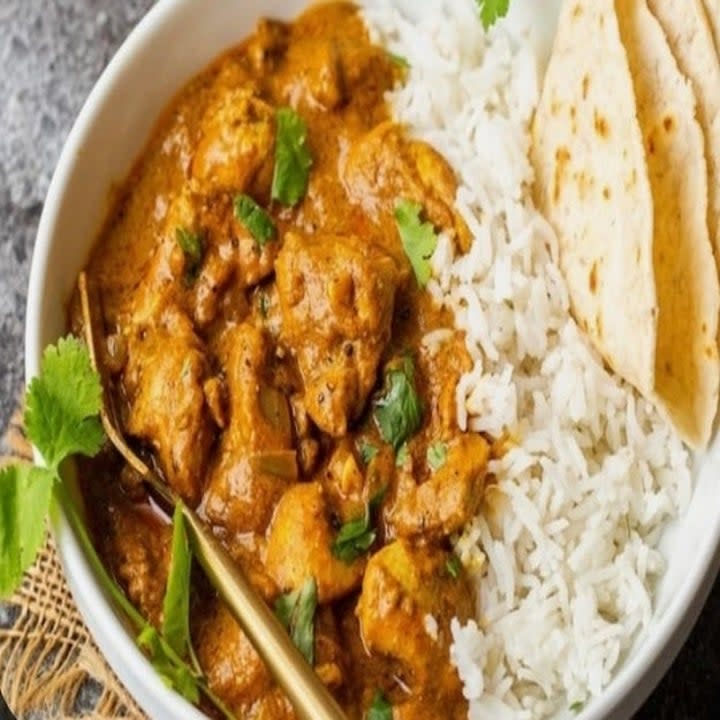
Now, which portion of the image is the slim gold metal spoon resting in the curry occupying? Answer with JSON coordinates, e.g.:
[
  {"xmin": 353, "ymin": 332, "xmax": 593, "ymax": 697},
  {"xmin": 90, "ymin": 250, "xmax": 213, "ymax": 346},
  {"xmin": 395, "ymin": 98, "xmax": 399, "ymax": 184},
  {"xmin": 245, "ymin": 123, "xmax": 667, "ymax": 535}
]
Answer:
[{"xmin": 78, "ymin": 272, "xmax": 346, "ymax": 720}]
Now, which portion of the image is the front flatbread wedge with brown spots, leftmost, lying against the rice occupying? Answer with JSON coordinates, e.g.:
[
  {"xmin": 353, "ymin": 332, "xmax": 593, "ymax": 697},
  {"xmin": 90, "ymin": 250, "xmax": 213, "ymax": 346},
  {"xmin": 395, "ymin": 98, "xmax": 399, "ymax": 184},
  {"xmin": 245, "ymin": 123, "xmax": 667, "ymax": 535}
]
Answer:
[{"xmin": 531, "ymin": 0, "xmax": 658, "ymax": 396}]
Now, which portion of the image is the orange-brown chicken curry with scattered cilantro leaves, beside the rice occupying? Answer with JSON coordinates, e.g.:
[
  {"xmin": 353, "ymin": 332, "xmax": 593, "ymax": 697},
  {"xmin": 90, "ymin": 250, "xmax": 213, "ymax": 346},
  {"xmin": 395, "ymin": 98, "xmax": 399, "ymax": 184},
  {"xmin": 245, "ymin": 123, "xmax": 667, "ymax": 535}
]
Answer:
[{"xmin": 71, "ymin": 3, "xmax": 490, "ymax": 720}]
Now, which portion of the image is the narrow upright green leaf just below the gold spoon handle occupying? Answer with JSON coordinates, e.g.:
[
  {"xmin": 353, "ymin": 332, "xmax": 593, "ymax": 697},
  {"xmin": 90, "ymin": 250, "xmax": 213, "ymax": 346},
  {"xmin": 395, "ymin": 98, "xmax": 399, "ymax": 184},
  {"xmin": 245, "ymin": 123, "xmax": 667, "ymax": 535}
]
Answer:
[{"xmin": 162, "ymin": 503, "xmax": 192, "ymax": 656}]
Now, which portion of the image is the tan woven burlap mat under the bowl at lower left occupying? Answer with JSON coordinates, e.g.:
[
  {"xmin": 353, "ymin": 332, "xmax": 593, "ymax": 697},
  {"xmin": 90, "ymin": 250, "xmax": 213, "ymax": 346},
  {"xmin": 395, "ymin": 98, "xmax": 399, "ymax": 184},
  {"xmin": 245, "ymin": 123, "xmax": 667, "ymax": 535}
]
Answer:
[{"xmin": 0, "ymin": 411, "xmax": 145, "ymax": 720}]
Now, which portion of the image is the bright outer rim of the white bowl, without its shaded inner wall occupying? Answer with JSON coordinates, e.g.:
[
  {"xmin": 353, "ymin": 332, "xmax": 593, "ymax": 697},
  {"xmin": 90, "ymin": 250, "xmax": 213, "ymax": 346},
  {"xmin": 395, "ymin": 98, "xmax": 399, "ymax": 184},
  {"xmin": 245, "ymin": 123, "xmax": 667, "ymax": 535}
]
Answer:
[{"xmin": 25, "ymin": 0, "xmax": 720, "ymax": 720}]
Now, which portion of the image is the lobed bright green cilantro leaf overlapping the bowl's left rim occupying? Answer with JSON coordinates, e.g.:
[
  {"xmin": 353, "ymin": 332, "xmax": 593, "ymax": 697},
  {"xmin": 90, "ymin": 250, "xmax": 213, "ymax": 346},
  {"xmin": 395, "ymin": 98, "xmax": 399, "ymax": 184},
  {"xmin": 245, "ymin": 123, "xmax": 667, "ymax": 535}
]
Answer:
[{"xmin": 25, "ymin": 337, "xmax": 105, "ymax": 470}]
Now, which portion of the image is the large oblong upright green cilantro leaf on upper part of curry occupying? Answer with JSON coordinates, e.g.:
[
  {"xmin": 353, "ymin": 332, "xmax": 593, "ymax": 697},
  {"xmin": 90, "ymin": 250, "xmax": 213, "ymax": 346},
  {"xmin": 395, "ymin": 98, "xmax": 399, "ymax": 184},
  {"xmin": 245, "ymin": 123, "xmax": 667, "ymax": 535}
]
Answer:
[{"xmin": 272, "ymin": 108, "xmax": 312, "ymax": 205}]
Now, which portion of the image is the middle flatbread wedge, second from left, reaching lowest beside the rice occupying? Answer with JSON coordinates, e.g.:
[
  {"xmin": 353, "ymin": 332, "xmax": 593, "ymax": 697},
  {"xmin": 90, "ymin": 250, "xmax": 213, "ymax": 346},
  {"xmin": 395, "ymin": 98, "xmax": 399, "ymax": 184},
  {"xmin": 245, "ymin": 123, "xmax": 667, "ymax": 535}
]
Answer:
[{"xmin": 616, "ymin": 0, "xmax": 720, "ymax": 448}]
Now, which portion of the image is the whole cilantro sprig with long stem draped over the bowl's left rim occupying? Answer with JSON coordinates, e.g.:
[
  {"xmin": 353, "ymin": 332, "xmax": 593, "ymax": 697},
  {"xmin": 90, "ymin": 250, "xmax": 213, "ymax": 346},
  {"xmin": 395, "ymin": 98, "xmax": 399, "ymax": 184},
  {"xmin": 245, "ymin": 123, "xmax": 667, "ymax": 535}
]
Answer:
[{"xmin": 0, "ymin": 336, "xmax": 234, "ymax": 720}]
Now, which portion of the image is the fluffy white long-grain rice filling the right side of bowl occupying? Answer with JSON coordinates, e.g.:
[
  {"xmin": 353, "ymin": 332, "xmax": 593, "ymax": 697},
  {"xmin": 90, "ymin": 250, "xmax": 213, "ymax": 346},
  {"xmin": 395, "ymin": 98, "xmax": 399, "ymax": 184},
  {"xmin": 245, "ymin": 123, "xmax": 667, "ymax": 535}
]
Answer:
[{"xmin": 365, "ymin": 0, "xmax": 691, "ymax": 720}]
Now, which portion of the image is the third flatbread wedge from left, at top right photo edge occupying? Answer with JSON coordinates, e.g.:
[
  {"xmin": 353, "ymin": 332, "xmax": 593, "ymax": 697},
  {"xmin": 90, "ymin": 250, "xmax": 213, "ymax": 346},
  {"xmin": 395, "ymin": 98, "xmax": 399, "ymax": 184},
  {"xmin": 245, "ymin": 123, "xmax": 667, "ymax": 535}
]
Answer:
[{"xmin": 648, "ymin": 0, "xmax": 720, "ymax": 269}]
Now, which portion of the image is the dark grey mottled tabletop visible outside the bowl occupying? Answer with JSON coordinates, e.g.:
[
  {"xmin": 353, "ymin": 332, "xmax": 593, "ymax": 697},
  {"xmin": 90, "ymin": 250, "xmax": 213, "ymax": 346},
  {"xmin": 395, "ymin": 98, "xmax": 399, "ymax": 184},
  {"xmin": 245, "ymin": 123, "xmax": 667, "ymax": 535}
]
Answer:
[{"xmin": 0, "ymin": 0, "xmax": 720, "ymax": 720}]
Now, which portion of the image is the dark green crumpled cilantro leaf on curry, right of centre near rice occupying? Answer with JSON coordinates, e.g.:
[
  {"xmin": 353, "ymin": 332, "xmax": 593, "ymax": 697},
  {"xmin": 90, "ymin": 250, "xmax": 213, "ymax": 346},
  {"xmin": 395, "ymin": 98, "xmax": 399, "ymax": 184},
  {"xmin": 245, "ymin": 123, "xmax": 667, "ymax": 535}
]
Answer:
[{"xmin": 374, "ymin": 356, "xmax": 423, "ymax": 452}]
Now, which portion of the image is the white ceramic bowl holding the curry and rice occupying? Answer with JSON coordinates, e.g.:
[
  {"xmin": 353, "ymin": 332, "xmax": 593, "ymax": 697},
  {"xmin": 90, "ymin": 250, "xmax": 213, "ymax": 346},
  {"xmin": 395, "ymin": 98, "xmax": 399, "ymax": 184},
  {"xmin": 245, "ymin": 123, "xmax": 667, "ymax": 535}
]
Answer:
[{"xmin": 25, "ymin": 0, "xmax": 720, "ymax": 720}]
